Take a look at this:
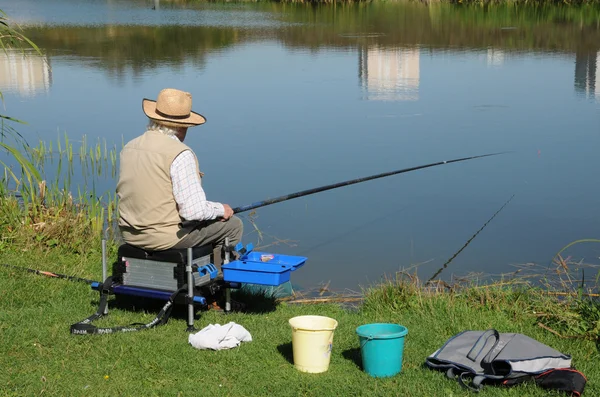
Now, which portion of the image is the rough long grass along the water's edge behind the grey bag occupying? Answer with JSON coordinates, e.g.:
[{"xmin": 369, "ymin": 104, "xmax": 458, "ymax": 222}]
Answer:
[{"xmin": 356, "ymin": 246, "xmax": 600, "ymax": 341}]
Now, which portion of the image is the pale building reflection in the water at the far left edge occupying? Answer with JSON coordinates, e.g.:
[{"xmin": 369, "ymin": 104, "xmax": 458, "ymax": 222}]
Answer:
[{"xmin": 0, "ymin": 50, "xmax": 52, "ymax": 97}]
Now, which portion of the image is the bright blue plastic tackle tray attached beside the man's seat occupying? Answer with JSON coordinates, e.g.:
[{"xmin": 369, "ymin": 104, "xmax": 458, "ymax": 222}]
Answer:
[{"xmin": 221, "ymin": 244, "xmax": 306, "ymax": 286}]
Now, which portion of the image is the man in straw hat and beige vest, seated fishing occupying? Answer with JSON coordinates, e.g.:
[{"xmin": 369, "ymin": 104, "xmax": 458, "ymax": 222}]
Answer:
[{"xmin": 117, "ymin": 88, "xmax": 243, "ymax": 270}]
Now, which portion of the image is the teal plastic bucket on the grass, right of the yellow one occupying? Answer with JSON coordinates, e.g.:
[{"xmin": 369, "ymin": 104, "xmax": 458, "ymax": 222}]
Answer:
[{"xmin": 356, "ymin": 323, "xmax": 408, "ymax": 378}]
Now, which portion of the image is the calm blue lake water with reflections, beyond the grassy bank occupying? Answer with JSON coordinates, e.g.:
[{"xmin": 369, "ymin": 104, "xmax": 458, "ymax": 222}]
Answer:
[{"xmin": 0, "ymin": 0, "xmax": 600, "ymax": 289}]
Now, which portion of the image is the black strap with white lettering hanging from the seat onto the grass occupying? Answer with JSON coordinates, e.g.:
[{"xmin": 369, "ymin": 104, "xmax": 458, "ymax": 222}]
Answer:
[{"xmin": 71, "ymin": 276, "xmax": 187, "ymax": 335}]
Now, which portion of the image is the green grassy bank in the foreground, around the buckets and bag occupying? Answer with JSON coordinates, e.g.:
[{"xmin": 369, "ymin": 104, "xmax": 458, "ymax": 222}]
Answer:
[{"xmin": 0, "ymin": 249, "xmax": 600, "ymax": 396}]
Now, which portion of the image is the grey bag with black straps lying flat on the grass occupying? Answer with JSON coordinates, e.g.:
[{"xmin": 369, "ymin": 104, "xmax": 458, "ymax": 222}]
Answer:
[{"xmin": 425, "ymin": 329, "xmax": 571, "ymax": 391}]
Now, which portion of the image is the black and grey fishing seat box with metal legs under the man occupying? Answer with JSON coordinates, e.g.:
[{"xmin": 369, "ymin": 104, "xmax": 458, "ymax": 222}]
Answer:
[{"xmin": 71, "ymin": 239, "xmax": 241, "ymax": 334}]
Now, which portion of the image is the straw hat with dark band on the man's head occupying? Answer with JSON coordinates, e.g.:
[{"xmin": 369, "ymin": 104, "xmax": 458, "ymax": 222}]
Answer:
[{"xmin": 142, "ymin": 88, "xmax": 206, "ymax": 127}]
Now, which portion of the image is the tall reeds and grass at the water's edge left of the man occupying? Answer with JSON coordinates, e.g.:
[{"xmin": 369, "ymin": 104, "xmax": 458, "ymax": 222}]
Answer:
[{"xmin": 0, "ymin": 134, "xmax": 118, "ymax": 252}]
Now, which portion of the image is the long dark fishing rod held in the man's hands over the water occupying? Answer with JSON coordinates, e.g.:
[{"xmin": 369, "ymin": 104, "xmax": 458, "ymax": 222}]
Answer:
[{"xmin": 179, "ymin": 152, "xmax": 507, "ymax": 228}]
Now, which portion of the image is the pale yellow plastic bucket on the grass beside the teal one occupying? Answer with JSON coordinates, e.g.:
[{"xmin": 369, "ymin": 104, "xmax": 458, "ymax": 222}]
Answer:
[{"xmin": 289, "ymin": 316, "xmax": 337, "ymax": 373}]
